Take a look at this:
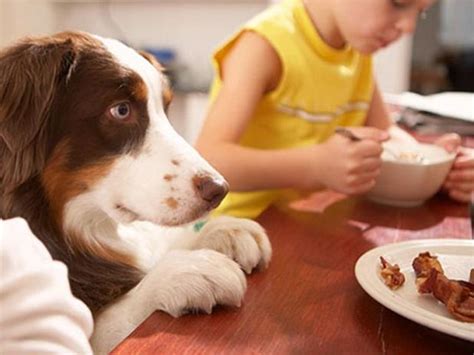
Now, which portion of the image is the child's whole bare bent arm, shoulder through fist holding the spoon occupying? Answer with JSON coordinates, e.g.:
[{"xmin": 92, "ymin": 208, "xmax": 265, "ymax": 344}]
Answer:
[{"xmin": 196, "ymin": 32, "xmax": 386, "ymax": 194}]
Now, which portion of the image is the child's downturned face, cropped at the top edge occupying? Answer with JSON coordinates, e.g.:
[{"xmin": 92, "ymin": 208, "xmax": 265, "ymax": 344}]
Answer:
[{"xmin": 329, "ymin": 0, "xmax": 435, "ymax": 54}]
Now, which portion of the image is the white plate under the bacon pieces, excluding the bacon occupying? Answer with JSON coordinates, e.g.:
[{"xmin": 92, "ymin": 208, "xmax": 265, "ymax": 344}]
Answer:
[{"xmin": 355, "ymin": 239, "xmax": 474, "ymax": 341}]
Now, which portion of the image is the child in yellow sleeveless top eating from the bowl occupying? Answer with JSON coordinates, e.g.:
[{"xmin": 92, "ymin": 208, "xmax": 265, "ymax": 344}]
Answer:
[{"xmin": 196, "ymin": 0, "xmax": 474, "ymax": 218}]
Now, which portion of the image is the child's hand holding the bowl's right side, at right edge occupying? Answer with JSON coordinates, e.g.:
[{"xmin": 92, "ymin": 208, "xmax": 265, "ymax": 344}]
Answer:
[{"xmin": 435, "ymin": 134, "xmax": 474, "ymax": 202}]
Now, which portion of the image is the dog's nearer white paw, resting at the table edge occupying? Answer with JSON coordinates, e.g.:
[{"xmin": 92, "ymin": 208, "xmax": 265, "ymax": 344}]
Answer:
[{"xmin": 146, "ymin": 249, "xmax": 247, "ymax": 317}]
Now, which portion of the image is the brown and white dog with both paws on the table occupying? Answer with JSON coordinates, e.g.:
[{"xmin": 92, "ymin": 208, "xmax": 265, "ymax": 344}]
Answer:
[{"xmin": 0, "ymin": 32, "xmax": 271, "ymax": 353}]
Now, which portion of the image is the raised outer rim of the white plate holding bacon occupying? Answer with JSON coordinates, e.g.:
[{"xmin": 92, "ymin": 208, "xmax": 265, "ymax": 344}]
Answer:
[{"xmin": 354, "ymin": 238, "xmax": 474, "ymax": 342}]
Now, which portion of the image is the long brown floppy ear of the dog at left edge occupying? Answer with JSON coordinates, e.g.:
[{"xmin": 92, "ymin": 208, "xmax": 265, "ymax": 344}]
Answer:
[{"xmin": 0, "ymin": 37, "xmax": 77, "ymax": 191}]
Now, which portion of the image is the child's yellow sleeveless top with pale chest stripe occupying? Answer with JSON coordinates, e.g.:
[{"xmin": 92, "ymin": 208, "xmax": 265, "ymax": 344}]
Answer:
[{"xmin": 210, "ymin": 0, "xmax": 373, "ymax": 218}]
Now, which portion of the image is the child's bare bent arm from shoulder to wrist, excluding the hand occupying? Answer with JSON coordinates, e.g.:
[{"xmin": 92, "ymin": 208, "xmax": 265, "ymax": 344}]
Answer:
[{"xmin": 196, "ymin": 32, "xmax": 308, "ymax": 191}]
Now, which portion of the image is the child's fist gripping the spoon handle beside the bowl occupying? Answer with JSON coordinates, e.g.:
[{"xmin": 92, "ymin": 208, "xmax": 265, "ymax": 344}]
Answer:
[{"xmin": 313, "ymin": 127, "xmax": 388, "ymax": 195}]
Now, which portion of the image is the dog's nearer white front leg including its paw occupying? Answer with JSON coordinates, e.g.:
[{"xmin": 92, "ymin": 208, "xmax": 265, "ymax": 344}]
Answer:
[{"xmin": 91, "ymin": 249, "xmax": 246, "ymax": 354}]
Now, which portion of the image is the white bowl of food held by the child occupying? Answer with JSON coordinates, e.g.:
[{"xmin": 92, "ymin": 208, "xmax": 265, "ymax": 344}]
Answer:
[{"xmin": 367, "ymin": 144, "xmax": 456, "ymax": 207}]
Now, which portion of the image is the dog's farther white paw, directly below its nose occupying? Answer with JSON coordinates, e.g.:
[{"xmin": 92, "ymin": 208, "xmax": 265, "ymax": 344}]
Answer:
[{"xmin": 194, "ymin": 216, "xmax": 272, "ymax": 274}]
